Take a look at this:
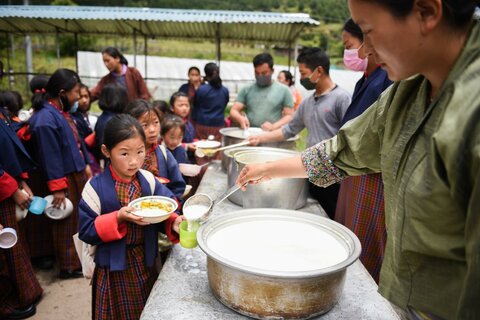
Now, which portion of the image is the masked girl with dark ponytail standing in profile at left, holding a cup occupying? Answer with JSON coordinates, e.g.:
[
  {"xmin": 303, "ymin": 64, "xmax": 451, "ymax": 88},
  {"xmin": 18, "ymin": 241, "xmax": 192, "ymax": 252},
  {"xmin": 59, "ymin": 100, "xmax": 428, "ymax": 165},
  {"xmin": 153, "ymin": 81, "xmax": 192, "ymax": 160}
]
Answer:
[{"xmin": 29, "ymin": 69, "xmax": 91, "ymax": 279}]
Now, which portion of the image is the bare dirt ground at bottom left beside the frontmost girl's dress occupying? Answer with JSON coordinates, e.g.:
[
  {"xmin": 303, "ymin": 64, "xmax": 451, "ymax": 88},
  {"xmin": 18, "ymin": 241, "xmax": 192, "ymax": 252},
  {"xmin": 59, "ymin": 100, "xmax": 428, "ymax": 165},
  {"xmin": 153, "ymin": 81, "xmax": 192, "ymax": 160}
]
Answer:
[{"xmin": 29, "ymin": 270, "xmax": 92, "ymax": 320}]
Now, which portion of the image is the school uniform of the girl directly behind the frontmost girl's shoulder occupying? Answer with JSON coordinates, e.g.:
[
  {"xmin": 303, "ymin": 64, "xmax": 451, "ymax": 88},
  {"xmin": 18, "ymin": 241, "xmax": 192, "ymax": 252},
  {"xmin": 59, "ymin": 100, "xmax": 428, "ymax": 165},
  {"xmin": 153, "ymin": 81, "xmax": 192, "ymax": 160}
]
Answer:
[{"xmin": 142, "ymin": 144, "xmax": 186, "ymax": 199}]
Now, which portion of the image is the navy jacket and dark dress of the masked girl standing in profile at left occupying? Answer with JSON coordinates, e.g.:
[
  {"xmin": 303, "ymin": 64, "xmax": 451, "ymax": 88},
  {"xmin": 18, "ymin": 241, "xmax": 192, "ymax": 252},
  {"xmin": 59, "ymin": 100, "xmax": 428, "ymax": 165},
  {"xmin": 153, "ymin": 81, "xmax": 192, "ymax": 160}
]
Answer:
[{"xmin": 30, "ymin": 102, "xmax": 86, "ymax": 272}]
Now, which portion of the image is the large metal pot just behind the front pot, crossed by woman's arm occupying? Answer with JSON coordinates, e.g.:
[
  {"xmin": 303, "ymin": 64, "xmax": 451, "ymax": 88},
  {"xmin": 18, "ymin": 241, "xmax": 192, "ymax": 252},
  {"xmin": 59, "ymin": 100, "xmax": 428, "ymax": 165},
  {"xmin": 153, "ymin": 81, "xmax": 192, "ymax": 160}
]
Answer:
[{"xmin": 233, "ymin": 150, "xmax": 308, "ymax": 209}]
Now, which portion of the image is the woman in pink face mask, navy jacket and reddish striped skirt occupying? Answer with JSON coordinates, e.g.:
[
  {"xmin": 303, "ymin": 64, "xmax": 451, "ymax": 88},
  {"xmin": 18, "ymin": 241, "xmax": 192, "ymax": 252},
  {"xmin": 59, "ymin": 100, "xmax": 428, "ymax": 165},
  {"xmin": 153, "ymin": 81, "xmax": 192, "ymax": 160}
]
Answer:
[{"xmin": 335, "ymin": 19, "xmax": 392, "ymax": 283}]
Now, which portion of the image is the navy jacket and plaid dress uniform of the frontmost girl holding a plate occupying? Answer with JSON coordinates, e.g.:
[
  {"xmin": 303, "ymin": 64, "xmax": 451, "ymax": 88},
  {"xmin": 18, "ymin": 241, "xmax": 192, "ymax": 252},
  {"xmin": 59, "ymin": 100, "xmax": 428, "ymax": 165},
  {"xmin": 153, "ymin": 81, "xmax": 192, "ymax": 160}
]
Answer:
[{"xmin": 79, "ymin": 167, "xmax": 178, "ymax": 319}]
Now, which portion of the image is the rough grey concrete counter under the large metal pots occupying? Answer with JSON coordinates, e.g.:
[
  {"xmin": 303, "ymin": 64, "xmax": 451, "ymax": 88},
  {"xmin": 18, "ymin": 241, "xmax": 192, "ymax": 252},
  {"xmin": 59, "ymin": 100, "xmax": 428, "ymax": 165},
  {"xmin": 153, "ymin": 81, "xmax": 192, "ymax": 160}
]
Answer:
[{"xmin": 141, "ymin": 162, "xmax": 400, "ymax": 320}]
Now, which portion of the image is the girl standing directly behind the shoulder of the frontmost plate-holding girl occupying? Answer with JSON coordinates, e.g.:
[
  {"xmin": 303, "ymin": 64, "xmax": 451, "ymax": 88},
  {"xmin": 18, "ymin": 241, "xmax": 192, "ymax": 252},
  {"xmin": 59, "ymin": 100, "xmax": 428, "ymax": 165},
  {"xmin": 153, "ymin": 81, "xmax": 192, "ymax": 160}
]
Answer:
[{"xmin": 127, "ymin": 99, "xmax": 186, "ymax": 199}]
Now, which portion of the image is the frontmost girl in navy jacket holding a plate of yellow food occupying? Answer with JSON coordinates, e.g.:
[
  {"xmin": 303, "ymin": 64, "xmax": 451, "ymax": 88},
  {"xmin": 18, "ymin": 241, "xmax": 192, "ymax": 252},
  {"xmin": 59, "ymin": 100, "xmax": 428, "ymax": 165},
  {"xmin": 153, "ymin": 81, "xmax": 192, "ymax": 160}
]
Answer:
[{"xmin": 79, "ymin": 114, "xmax": 183, "ymax": 319}]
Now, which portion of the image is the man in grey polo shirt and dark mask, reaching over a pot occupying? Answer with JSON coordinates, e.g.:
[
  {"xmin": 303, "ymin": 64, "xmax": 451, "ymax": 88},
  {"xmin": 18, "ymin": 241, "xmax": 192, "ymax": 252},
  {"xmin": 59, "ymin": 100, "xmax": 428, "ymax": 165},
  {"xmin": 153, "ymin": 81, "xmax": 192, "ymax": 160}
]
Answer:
[{"xmin": 248, "ymin": 48, "xmax": 350, "ymax": 219}]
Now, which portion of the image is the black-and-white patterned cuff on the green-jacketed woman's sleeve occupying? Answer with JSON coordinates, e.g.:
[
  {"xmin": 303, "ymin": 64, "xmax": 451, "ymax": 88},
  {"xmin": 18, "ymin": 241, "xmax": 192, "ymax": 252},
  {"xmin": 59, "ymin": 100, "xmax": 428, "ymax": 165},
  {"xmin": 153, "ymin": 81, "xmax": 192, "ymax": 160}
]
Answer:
[{"xmin": 302, "ymin": 142, "xmax": 346, "ymax": 187}]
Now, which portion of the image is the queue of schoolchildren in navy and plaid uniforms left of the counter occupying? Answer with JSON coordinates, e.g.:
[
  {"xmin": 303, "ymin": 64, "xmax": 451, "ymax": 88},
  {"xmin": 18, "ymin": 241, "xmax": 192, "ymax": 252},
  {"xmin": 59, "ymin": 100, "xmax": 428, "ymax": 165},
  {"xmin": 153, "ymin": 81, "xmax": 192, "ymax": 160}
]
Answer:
[{"xmin": 0, "ymin": 54, "xmax": 234, "ymax": 319}]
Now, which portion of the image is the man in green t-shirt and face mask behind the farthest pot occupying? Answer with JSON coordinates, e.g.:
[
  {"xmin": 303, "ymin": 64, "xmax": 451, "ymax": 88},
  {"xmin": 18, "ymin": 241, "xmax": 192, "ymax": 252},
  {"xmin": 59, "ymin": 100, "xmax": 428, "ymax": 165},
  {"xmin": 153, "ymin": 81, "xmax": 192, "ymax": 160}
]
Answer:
[{"xmin": 230, "ymin": 53, "xmax": 294, "ymax": 131}]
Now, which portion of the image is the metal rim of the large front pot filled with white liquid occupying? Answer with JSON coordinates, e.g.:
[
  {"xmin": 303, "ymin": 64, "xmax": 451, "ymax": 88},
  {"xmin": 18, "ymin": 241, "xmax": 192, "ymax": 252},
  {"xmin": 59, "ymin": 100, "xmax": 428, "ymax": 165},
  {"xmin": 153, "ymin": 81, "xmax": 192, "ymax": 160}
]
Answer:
[{"xmin": 197, "ymin": 208, "xmax": 361, "ymax": 279}]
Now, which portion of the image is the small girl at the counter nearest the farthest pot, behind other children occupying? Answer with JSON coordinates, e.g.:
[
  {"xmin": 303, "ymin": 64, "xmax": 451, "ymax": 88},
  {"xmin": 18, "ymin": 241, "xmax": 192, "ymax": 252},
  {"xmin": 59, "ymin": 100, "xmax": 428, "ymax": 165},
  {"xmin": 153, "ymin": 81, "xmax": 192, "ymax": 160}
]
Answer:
[{"xmin": 170, "ymin": 91, "xmax": 197, "ymax": 158}]
